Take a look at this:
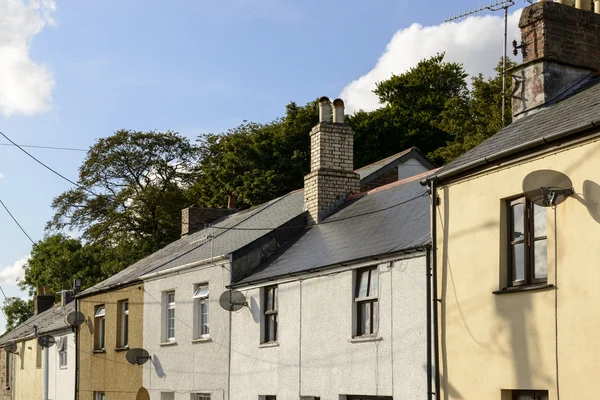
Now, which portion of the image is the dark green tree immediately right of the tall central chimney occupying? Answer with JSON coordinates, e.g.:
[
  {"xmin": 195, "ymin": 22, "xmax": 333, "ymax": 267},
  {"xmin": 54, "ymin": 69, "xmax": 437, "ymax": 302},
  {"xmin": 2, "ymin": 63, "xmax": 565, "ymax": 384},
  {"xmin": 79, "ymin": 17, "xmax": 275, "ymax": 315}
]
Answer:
[{"xmin": 348, "ymin": 54, "xmax": 467, "ymax": 167}]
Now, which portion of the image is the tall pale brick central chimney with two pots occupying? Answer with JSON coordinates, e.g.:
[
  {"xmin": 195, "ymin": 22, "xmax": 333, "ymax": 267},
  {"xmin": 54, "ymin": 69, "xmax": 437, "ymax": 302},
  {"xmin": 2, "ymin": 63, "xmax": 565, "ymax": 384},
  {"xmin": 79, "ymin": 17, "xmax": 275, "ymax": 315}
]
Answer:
[{"xmin": 304, "ymin": 97, "xmax": 360, "ymax": 224}]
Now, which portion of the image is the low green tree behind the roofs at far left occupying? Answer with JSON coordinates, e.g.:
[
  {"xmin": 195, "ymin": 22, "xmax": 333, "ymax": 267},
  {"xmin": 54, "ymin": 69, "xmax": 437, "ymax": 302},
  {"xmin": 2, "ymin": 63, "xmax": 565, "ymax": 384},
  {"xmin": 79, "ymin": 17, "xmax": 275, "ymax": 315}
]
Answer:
[{"xmin": 18, "ymin": 234, "xmax": 121, "ymax": 296}]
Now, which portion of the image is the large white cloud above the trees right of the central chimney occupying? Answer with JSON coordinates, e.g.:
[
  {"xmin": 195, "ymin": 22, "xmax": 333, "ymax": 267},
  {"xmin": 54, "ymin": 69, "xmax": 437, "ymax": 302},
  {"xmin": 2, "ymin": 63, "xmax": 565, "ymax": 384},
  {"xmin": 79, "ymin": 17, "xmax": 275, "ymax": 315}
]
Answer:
[{"xmin": 340, "ymin": 10, "xmax": 521, "ymax": 113}]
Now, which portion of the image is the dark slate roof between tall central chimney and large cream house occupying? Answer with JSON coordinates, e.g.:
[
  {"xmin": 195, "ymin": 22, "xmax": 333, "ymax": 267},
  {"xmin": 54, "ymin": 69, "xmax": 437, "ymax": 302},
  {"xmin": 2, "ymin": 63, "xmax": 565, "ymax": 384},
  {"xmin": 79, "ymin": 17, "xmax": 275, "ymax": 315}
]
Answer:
[{"xmin": 233, "ymin": 171, "xmax": 434, "ymax": 286}]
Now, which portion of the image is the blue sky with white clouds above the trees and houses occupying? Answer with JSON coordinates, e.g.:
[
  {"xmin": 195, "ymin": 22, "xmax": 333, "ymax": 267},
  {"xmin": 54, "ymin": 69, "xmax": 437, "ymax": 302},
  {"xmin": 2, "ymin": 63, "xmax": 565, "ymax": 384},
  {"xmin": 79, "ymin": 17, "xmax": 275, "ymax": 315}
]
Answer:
[{"xmin": 0, "ymin": 0, "xmax": 527, "ymax": 328}]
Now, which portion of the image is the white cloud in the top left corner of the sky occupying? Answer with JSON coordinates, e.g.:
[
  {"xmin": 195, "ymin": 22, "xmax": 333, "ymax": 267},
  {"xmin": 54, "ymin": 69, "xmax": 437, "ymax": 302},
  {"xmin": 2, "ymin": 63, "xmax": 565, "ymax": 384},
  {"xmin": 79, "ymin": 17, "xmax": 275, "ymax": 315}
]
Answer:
[{"xmin": 0, "ymin": 0, "xmax": 56, "ymax": 116}]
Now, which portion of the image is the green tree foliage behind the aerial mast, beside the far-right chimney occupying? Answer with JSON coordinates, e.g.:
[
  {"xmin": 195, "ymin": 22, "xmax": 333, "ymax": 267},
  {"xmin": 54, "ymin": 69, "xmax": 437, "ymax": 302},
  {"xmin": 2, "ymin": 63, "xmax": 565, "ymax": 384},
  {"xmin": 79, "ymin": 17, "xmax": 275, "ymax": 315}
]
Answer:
[{"xmin": 430, "ymin": 60, "xmax": 516, "ymax": 164}]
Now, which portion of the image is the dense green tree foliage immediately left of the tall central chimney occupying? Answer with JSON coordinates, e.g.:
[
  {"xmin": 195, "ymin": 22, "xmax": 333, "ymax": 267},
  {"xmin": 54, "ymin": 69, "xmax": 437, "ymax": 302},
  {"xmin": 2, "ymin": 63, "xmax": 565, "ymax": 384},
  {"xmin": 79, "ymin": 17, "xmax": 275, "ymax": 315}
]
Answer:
[{"xmin": 191, "ymin": 101, "xmax": 319, "ymax": 207}]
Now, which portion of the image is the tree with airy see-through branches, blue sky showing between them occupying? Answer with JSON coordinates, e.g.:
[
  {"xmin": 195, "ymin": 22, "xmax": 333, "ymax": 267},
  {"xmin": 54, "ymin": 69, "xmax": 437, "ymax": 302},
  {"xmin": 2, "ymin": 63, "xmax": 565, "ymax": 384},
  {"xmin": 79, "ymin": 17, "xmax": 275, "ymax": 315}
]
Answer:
[{"xmin": 47, "ymin": 130, "xmax": 198, "ymax": 267}]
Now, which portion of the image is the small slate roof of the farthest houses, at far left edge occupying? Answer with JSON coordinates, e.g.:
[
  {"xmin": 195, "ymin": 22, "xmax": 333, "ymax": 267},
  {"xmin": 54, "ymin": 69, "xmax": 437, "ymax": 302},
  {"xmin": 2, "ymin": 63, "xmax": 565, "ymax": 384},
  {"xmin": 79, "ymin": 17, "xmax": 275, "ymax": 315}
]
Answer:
[{"xmin": 0, "ymin": 301, "xmax": 75, "ymax": 346}]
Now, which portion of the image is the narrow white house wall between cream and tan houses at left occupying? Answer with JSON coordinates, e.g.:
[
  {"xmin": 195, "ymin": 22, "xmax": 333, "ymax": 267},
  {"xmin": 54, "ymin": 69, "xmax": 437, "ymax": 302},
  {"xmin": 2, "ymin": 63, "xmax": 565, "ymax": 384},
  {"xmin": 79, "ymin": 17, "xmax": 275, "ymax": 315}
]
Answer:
[{"xmin": 48, "ymin": 330, "xmax": 76, "ymax": 400}]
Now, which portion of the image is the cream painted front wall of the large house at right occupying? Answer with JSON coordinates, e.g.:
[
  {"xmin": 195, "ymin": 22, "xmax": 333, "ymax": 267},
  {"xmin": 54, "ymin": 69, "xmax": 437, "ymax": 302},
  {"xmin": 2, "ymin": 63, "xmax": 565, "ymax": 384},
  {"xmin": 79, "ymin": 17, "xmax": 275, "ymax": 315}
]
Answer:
[{"xmin": 437, "ymin": 136, "xmax": 600, "ymax": 400}]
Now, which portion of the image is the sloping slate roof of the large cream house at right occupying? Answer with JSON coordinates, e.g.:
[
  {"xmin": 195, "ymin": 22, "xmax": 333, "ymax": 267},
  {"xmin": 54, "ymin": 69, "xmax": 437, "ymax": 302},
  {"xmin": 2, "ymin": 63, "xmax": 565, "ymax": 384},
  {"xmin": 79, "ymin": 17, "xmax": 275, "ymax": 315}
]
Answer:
[{"xmin": 437, "ymin": 74, "xmax": 600, "ymax": 181}]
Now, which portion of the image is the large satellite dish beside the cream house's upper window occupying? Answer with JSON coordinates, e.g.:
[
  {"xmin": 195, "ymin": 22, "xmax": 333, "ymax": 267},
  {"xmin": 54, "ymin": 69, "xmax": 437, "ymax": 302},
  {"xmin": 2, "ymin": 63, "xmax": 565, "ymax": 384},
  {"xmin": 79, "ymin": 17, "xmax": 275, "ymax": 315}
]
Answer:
[{"xmin": 523, "ymin": 169, "xmax": 575, "ymax": 207}]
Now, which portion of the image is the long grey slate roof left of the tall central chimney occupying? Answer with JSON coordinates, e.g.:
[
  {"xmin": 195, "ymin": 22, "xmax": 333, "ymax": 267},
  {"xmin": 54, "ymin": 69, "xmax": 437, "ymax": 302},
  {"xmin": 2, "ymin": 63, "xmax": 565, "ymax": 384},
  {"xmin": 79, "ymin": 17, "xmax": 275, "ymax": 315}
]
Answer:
[{"xmin": 79, "ymin": 190, "xmax": 304, "ymax": 296}]
